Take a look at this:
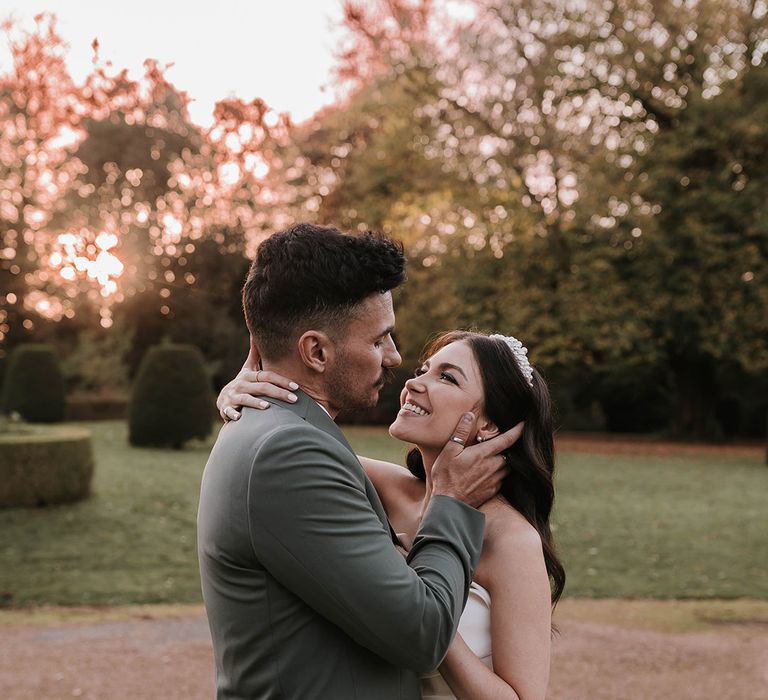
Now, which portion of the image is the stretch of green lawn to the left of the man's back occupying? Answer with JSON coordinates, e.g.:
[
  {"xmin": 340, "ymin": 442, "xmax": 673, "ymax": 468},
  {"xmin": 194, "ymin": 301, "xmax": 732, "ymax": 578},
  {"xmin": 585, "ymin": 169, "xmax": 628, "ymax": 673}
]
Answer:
[{"xmin": 0, "ymin": 422, "xmax": 209, "ymax": 605}]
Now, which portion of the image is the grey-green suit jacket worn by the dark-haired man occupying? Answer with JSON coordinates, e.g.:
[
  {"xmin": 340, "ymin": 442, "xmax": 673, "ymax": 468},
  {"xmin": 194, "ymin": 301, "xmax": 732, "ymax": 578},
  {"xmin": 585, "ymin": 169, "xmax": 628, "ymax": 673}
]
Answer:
[{"xmin": 198, "ymin": 392, "xmax": 485, "ymax": 700}]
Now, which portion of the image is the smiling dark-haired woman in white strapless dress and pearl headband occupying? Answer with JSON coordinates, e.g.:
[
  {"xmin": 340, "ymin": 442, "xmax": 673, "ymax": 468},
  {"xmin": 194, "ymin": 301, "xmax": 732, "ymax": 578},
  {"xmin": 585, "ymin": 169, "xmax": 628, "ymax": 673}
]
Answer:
[{"xmin": 217, "ymin": 331, "xmax": 565, "ymax": 700}]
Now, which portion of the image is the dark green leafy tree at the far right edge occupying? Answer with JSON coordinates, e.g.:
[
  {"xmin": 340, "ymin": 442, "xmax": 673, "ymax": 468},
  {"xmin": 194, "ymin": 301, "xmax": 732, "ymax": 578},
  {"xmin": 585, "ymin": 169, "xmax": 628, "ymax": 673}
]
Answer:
[{"xmin": 643, "ymin": 66, "xmax": 768, "ymax": 436}]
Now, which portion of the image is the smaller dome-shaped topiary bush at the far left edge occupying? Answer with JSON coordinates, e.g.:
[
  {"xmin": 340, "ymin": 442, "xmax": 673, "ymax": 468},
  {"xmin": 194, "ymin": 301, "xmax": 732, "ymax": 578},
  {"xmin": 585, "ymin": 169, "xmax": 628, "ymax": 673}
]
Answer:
[{"xmin": 0, "ymin": 343, "xmax": 67, "ymax": 423}]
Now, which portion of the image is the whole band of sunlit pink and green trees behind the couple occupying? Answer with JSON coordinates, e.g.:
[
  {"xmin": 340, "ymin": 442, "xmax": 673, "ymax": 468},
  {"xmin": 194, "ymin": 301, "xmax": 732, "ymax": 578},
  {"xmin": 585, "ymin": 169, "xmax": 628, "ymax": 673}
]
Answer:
[{"xmin": 0, "ymin": 0, "xmax": 768, "ymax": 439}]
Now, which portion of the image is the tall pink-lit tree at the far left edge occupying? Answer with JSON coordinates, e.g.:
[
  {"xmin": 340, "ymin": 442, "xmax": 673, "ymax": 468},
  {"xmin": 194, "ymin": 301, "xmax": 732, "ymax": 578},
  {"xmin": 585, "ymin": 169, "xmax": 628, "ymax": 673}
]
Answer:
[{"xmin": 0, "ymin": 14, "xmax": 82, "ymax": 357}]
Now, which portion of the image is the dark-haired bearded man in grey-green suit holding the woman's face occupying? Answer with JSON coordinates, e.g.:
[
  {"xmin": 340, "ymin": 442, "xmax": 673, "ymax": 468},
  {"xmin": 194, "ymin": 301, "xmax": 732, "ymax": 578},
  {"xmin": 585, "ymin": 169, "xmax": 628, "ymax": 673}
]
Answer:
[{"xmin": 198, "ymin": 224, "xmax": 515, "ymax": 700}]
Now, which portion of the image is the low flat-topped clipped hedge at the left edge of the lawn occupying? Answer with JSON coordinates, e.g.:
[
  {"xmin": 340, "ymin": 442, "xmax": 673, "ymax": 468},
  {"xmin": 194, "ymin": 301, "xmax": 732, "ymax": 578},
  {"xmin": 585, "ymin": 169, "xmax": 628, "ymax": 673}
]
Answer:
[{"xmin": 0, "ymin": 427, "xmax": 94, "ymax": 507}]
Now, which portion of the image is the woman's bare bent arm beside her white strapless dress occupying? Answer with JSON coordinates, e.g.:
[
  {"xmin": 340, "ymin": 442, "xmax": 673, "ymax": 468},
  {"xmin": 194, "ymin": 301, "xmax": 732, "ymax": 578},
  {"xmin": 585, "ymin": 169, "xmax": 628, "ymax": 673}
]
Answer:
[{"xmin": 440, "ymin": 529, "xmax": 552, "ymax": 700}]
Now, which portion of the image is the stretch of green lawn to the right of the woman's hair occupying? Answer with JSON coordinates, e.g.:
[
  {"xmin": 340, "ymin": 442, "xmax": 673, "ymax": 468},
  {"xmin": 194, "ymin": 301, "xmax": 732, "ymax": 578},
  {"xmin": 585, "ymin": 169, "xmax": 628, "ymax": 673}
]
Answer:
[{"xmin": 555, "ymin": 453, "xmax": 768, "ymax": 598}]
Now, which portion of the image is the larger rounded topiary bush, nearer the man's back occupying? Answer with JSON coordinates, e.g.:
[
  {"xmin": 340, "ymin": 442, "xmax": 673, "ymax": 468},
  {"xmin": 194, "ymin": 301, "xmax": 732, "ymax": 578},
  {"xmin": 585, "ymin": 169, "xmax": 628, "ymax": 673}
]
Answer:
[{"xmin": 128, "ymin": 345, "xmax": 214, "ymax": 449}]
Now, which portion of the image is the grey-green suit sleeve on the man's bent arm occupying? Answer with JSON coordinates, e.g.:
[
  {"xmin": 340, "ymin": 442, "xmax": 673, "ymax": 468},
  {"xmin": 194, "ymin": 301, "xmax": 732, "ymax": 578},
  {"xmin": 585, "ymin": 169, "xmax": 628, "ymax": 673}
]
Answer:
[{"xmin": 248, "ymin": 427, "xmax": 485, "ymax": 672}]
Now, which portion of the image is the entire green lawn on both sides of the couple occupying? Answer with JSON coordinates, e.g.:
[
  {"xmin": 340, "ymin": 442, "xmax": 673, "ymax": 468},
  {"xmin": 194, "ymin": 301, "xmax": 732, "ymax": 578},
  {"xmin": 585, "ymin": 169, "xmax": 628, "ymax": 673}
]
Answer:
[{"xmin": 0, "ymin": 422, "xmax": 768, "ymax": 606}]
